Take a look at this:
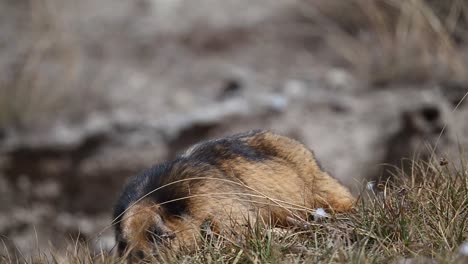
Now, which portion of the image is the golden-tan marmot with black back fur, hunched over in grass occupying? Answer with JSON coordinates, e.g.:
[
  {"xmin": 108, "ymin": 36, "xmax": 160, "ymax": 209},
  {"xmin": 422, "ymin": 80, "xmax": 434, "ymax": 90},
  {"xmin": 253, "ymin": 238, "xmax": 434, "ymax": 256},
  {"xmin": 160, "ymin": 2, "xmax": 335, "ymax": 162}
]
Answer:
[{"xmin": 114, "ymin": 130, "xmax": 355, "ymax": 257}]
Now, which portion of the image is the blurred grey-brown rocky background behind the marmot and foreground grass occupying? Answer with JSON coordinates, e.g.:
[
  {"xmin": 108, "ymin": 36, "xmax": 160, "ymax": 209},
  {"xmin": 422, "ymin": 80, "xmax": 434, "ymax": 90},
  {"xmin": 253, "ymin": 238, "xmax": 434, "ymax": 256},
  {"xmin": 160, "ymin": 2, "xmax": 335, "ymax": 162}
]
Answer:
[{"xmin": 0, "ymin": 0, "xmax": 468, "ymax": 255}]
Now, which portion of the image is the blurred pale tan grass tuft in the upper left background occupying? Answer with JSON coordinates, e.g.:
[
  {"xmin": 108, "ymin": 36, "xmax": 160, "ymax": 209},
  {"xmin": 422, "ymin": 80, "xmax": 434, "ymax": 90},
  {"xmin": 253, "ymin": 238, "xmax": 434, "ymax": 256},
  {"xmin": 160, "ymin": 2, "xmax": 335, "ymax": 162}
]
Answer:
[{"xmin": 0, "ymin": 0, "xmax": 78, "ymax": 127}]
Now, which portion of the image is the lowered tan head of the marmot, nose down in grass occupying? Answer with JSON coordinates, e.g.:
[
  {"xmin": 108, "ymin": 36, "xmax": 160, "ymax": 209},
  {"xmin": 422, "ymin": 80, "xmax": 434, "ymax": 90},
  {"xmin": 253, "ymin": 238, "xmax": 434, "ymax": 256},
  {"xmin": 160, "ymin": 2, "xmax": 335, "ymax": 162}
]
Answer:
[{"xmin": 116, "ymin": 199, "xmax": 176, "ymax": 258}]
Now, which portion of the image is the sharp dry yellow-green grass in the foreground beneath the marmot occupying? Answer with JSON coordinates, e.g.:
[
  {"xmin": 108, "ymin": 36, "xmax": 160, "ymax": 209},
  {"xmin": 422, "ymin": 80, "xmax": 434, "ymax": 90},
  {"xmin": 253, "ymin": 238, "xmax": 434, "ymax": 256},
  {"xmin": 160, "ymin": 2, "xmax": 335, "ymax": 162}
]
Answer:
[{"xmin": 3, "ymin": 156, "xmax": 468, "ymax": 263}]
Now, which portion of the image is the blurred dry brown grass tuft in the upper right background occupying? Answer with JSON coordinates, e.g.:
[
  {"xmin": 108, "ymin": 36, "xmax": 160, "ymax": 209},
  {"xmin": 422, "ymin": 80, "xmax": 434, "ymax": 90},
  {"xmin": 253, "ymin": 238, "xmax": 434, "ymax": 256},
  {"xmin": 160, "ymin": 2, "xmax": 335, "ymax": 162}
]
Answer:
[{"xmin": 302, "ymin": 0, "xmax": 468, "ymax": 85}]
